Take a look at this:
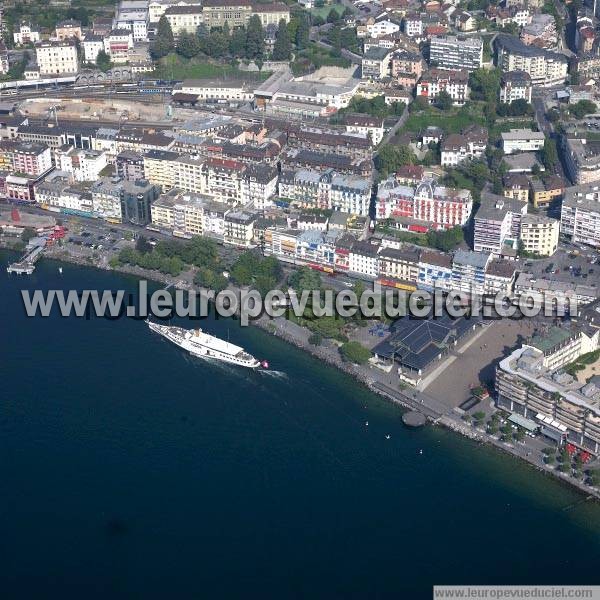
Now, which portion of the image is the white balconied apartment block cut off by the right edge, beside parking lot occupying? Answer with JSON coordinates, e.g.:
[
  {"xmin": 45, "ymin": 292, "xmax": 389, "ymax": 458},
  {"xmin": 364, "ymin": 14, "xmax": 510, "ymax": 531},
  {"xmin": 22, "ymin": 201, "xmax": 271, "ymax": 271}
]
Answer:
[{"xmin": 560, "ymin": 184, "xmax": 600, "ymax": 247}]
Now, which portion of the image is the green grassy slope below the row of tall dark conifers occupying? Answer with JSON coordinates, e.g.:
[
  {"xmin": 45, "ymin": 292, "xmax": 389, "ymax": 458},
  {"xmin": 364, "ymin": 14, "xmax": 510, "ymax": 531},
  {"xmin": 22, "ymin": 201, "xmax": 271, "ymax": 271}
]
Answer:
[{"xmin": 153, "ymin": 54, "xmax": 271, "ymax": 81}]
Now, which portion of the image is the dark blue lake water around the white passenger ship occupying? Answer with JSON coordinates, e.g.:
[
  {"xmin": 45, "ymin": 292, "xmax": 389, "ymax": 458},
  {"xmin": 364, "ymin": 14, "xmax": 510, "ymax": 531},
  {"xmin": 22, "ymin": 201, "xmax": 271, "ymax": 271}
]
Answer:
[{"xmin": 0, "ymin": 254, "xmax": 600, "ymax": 599}]
